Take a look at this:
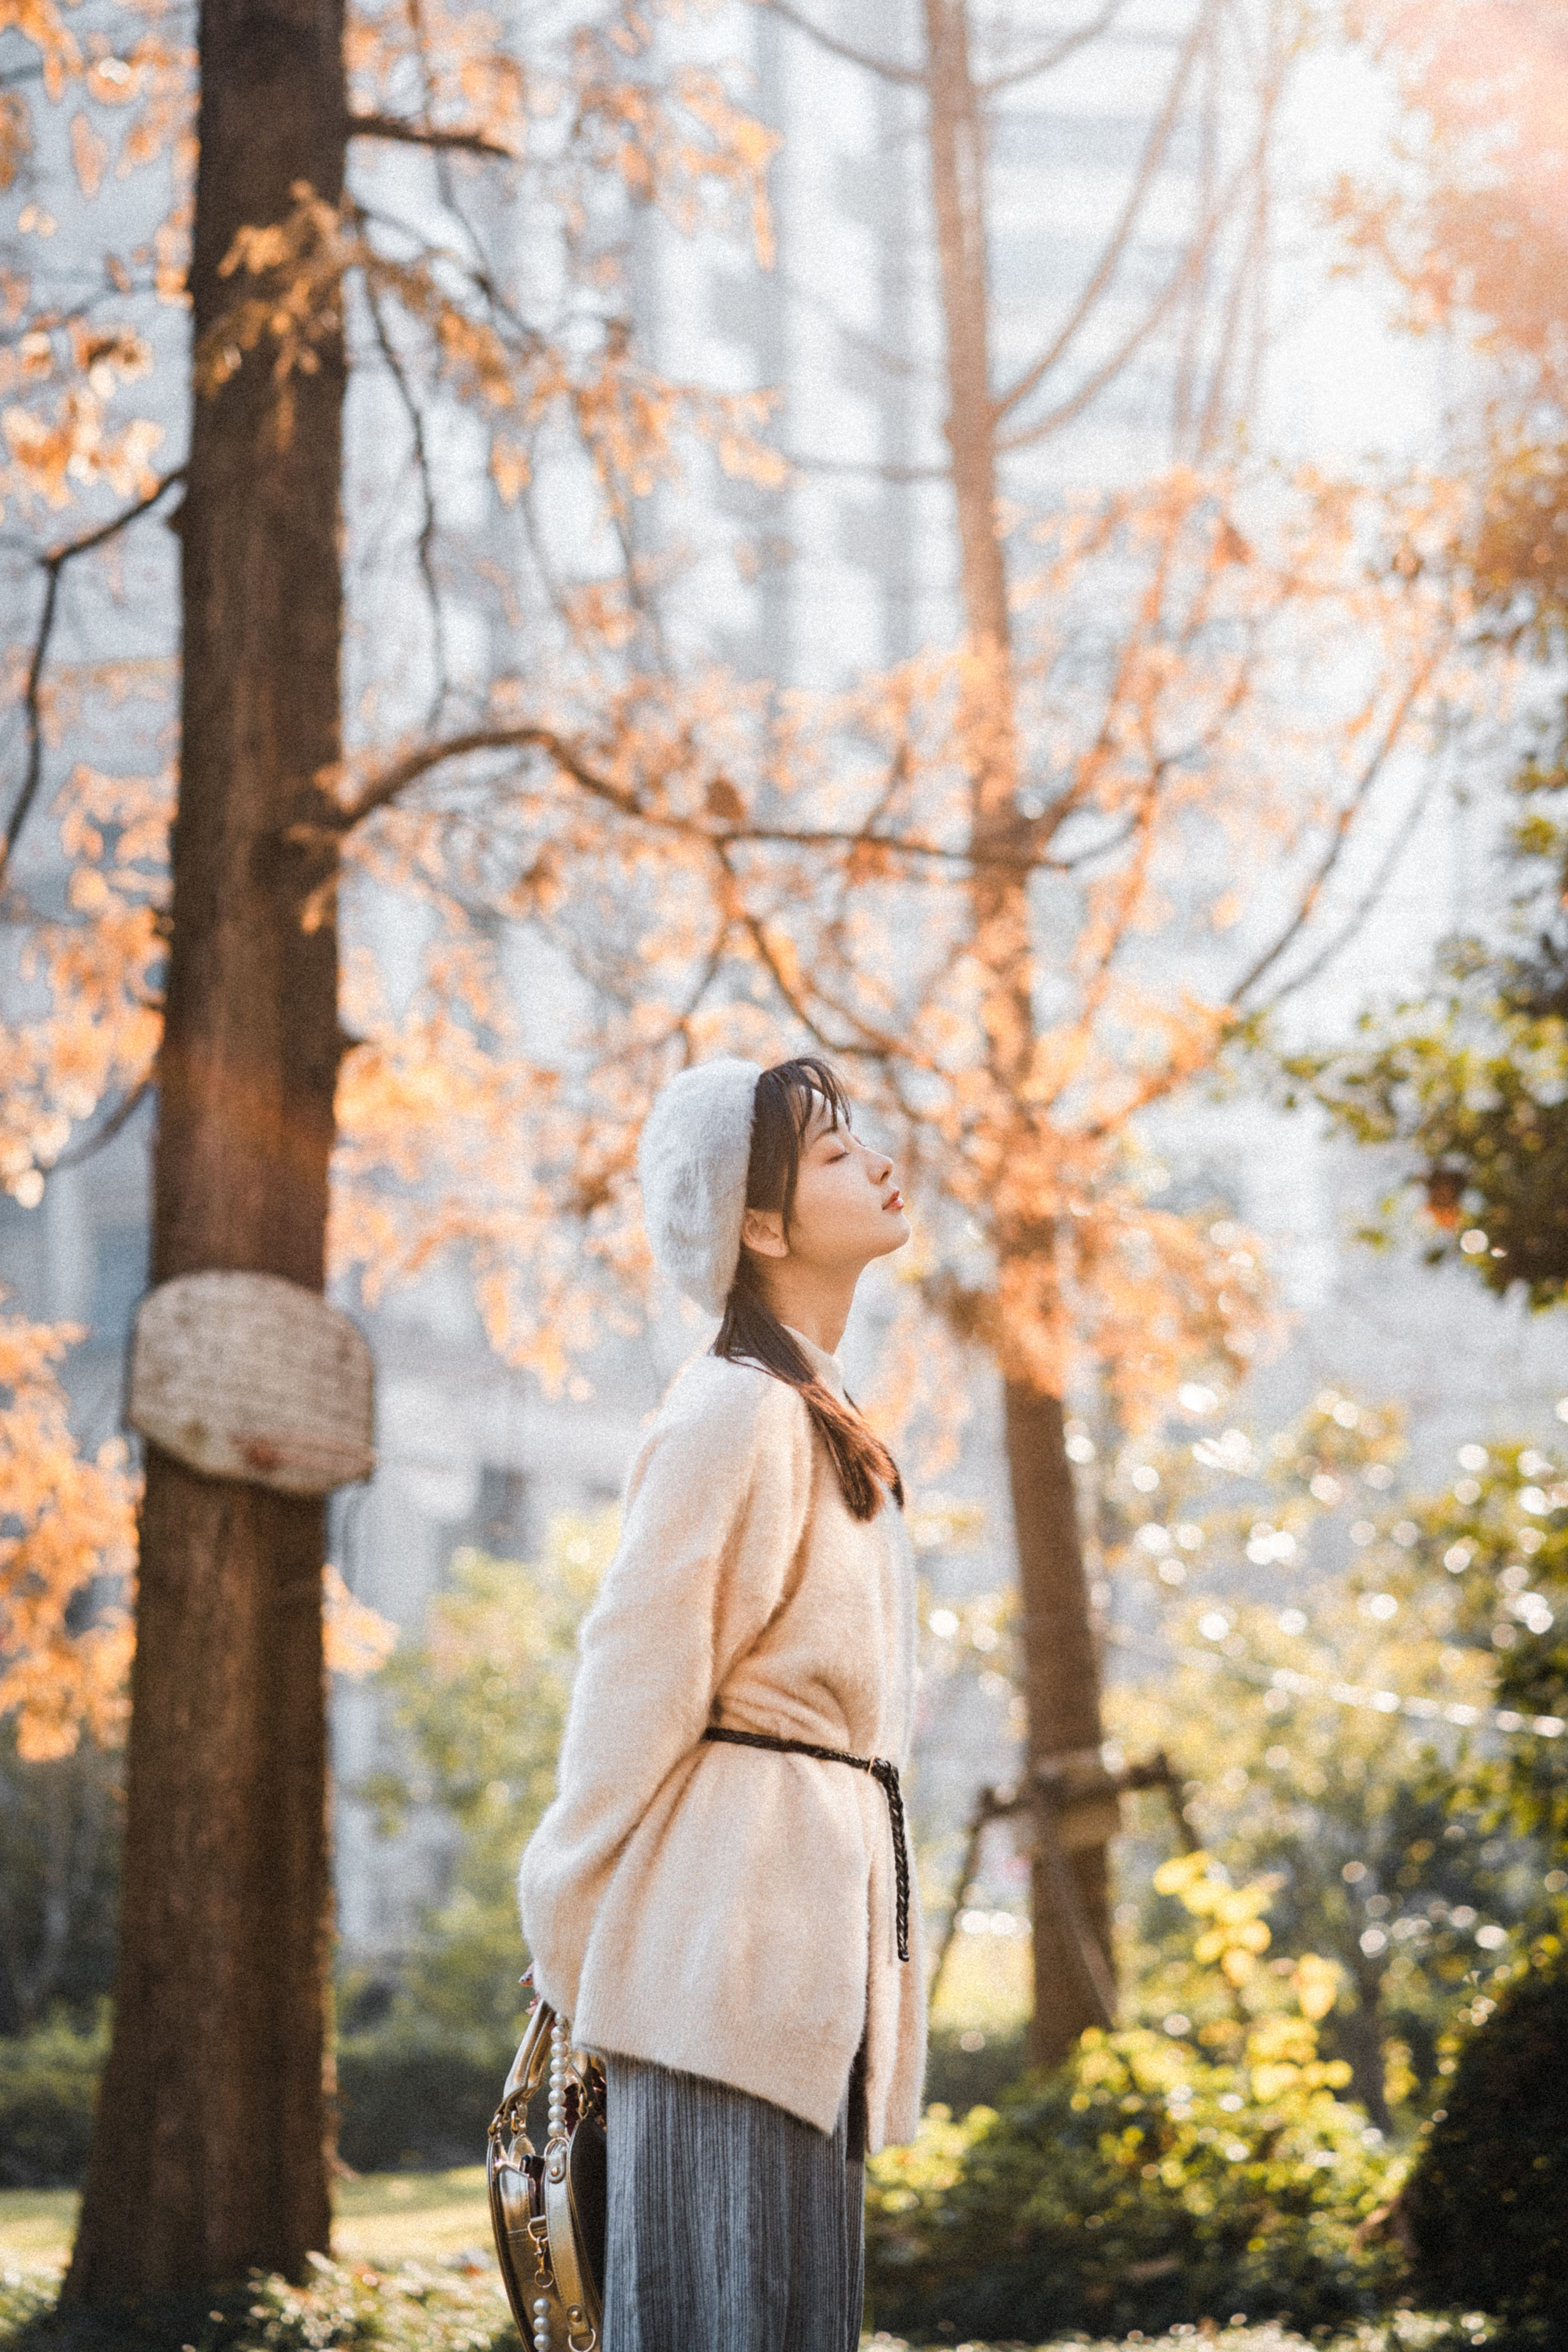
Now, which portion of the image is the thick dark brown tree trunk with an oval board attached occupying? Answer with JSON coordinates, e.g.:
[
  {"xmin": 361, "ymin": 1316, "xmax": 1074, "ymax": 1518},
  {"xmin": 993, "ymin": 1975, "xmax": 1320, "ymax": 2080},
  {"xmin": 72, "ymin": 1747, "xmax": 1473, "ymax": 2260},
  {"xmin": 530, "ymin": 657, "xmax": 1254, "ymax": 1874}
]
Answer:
[{"xmin": 66, "ymin": 0, "xmax": 346, "ymax": 2303}]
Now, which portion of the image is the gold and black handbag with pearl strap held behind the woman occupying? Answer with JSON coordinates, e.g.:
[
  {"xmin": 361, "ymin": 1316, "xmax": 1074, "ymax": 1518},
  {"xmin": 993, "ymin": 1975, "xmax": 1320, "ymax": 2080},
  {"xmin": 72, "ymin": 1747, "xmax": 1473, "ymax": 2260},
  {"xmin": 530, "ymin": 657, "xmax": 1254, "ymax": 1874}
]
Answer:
[{"xmin": 484, "ymin": 2002, "xmax": 609, "ymax": 2352}]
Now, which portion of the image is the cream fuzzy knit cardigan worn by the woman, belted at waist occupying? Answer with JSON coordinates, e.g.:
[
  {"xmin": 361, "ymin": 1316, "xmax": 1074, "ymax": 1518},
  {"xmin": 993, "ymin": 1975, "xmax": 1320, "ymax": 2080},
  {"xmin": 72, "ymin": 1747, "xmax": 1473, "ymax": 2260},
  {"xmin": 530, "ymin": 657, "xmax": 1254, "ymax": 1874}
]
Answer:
[{"xmin": 520, "ymin": 1333, "xmax": 926, "ymax": 2152}]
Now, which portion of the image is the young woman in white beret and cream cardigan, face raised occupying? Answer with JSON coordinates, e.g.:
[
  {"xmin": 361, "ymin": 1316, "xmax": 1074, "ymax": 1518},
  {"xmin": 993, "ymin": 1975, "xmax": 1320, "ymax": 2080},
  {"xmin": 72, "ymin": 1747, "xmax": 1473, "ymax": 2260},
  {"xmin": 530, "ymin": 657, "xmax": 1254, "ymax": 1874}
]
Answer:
[{"xmin": 520, "ymin": 1061, "xmax": 926, "ymax": 2352}]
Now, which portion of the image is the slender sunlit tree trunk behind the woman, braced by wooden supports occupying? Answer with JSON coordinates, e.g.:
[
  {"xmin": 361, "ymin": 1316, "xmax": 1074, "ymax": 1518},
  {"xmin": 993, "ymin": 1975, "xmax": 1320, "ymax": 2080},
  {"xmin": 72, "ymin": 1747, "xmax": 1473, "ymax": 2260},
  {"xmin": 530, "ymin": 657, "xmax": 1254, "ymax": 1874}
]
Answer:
[{"xmin": 926, "ymin": 0, "xmax": 1110, "ymax": 2065}]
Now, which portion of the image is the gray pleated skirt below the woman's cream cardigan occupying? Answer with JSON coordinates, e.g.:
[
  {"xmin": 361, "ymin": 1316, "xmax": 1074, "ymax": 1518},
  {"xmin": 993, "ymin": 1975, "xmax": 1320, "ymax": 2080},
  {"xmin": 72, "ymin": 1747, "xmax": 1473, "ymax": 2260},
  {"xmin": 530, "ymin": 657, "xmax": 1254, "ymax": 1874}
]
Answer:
[{"xmin": 604, "ymin": 2058, "xmax": 865, "ymax": 2352}]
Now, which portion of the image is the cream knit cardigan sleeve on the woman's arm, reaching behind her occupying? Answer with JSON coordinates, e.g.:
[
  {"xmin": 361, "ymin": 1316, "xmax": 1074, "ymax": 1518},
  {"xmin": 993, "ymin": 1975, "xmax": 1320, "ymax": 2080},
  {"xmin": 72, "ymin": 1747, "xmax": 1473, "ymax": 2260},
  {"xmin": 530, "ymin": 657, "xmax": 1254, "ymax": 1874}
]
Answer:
[{"xmin": 517, "ymin": 1360, "xmax": 811, "ymax": 2016}]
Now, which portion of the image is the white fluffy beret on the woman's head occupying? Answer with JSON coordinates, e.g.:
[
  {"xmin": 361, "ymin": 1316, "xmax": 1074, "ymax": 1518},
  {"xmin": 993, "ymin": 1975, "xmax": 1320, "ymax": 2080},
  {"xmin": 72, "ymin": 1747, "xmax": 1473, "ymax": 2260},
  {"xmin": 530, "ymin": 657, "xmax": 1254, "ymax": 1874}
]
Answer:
[{"xmin": 637, "ymin": 1056, "xmax": 762, "ymax": 1315}]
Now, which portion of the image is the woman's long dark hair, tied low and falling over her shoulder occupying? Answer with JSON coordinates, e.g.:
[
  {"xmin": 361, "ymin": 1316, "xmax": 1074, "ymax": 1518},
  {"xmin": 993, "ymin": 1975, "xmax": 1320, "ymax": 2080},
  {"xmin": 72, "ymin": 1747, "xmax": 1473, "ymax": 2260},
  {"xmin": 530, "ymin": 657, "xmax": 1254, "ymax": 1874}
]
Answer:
[{"xmin": 713, "ymin": 1053, "xmax": 902, "ymax": 1519}]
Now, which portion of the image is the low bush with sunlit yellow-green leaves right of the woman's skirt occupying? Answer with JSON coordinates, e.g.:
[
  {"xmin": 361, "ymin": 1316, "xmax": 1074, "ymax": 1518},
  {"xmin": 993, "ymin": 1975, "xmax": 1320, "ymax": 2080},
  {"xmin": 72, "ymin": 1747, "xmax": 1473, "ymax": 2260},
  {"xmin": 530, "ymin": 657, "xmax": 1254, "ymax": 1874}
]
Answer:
[{"xmin": 868, "ymin": 2016, "xmax": 1396, "ymax": 2343}]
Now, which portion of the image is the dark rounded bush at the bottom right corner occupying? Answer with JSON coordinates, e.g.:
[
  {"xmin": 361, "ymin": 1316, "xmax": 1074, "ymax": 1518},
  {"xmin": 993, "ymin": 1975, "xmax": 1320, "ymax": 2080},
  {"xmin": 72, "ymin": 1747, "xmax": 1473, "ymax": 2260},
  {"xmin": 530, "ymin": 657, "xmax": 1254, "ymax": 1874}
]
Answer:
[{"xmin": 1401, "ymin": 1938, "xmax": 1568, "ymax": 2343}]
